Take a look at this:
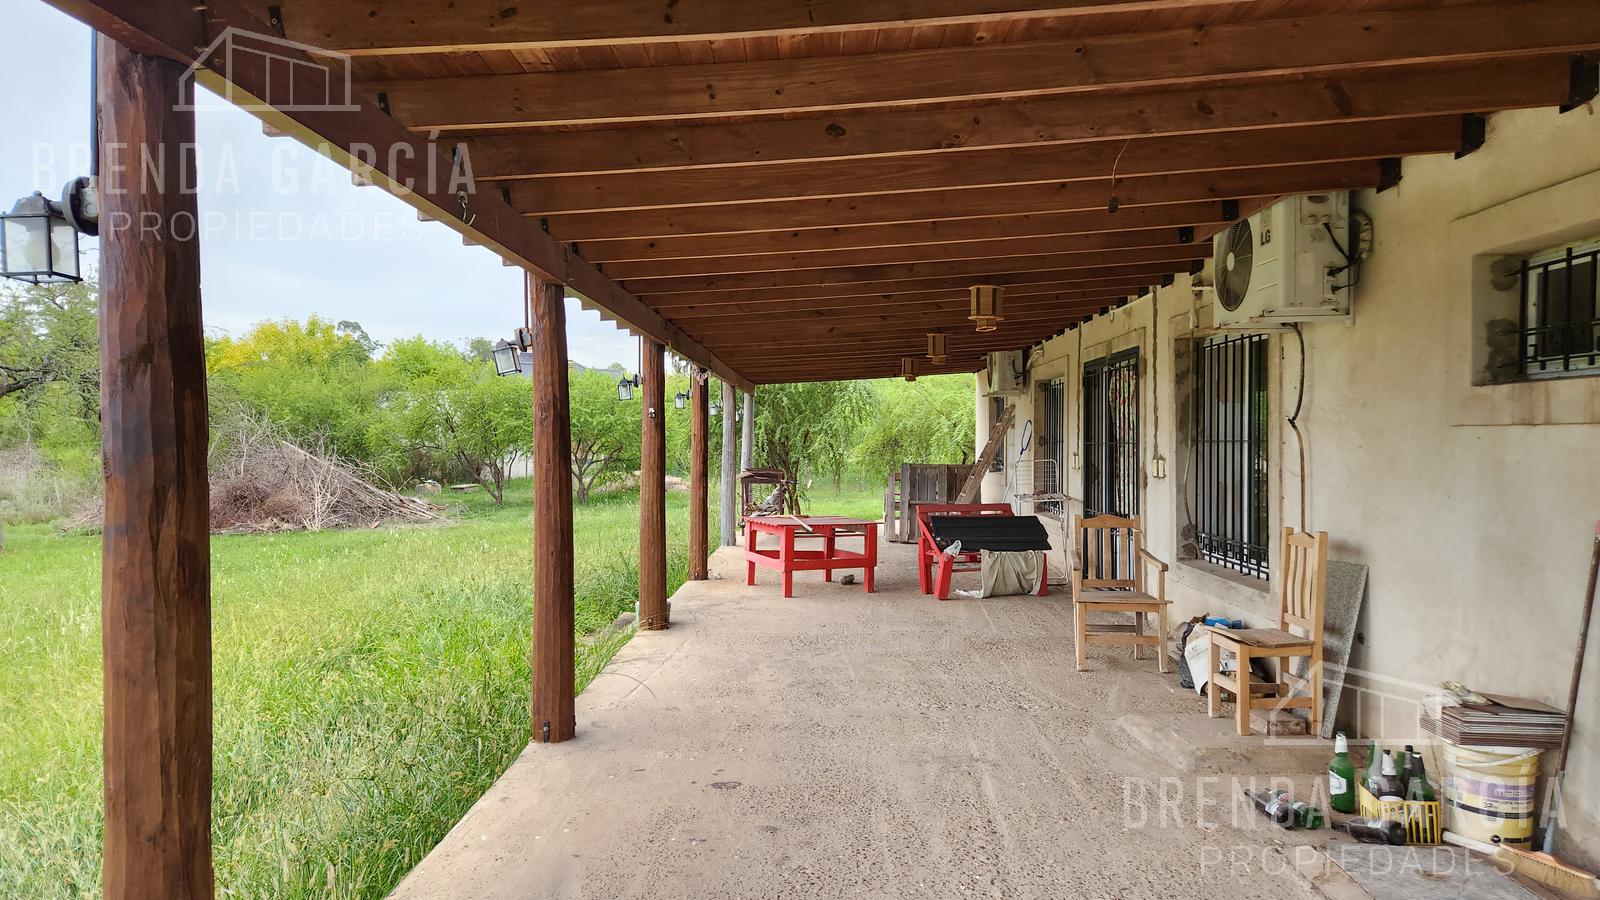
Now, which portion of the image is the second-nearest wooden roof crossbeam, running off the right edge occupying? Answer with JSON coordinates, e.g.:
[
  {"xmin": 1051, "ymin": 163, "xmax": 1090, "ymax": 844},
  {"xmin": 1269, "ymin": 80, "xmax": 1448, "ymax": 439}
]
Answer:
[{"xmin": 370, "ymin": 0, "xmax": 1600, "ymax": 130}]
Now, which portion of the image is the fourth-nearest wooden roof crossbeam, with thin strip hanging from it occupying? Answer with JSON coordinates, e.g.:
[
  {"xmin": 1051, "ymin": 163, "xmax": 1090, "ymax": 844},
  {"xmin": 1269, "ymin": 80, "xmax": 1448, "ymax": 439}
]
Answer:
[{"xmin": 510, "ymin": 115, "xmax": 1462, "ymax": 216}]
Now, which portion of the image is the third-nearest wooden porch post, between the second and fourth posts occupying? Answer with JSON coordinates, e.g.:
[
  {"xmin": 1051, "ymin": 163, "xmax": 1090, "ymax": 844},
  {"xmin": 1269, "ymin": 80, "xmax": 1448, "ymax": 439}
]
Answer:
[{"xmin": 638, "ymin": 338, "xmax": 667, "ymax": 631}]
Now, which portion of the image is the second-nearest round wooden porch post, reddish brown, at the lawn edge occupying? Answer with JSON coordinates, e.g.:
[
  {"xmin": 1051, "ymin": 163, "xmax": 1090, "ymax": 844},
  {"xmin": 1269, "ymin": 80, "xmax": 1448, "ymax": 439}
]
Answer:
[{"xmin": 528, "ymin": 274, "xmax": 576, "ymax": 743}]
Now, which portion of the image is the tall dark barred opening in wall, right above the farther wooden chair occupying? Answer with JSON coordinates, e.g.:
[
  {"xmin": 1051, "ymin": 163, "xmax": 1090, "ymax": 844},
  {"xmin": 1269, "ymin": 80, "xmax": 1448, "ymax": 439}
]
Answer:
[{"xmin": 1083, "ymin": 348, "xmax": 1139, "ymax": 519}]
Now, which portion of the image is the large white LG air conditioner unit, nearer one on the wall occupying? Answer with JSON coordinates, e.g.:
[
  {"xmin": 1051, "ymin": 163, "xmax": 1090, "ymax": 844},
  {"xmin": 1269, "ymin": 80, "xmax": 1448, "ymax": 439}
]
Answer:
[{"xmin": 1211, "ymin": 192, "xmax": 1354, "ymax": 328}]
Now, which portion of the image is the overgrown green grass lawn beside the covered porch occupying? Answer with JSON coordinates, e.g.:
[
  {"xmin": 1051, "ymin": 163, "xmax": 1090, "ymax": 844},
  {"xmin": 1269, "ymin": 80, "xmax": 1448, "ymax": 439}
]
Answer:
[{"xmin": 0, "ymin": 482, "xmax": 882, "ymax": 898}]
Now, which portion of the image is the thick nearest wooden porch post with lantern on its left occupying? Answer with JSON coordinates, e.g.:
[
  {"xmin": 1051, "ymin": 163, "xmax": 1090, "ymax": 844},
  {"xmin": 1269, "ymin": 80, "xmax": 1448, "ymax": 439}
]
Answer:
[{"xmin": 96, "ymin": 37, "xmax": 214, "ymax": 900}]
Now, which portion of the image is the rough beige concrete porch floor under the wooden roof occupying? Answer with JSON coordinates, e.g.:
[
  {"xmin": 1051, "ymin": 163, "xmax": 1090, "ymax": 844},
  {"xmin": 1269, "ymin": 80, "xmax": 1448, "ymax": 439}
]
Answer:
[{"xmin": 394, "ymin": 534, "xmax": 1326, "ymax": 900}]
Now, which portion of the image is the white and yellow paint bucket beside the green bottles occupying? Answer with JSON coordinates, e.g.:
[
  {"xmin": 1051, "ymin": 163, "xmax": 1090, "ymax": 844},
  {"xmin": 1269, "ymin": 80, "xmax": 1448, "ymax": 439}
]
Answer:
[{"xmin": 1445, "ymin": 741, "xmax": 1542, "ymax": 846}]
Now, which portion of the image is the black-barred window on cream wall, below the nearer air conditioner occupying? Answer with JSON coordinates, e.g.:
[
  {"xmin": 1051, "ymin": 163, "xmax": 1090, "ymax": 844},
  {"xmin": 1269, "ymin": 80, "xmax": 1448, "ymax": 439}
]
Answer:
[{"xmin": 1190, "ymin": 335, "xmax": 1269, "ymax": 578}]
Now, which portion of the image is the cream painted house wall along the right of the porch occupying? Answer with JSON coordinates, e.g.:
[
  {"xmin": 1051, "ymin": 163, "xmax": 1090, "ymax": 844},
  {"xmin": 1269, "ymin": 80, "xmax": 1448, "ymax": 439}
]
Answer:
[{"xmin": 979, "ymin": 109, "xmax": 1600, "ymax": 865}]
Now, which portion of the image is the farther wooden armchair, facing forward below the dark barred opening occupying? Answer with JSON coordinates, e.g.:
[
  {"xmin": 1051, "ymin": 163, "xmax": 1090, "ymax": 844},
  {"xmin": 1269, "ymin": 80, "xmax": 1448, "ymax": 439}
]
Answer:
[{"xmin": 1072, "ymin": 516, "xmax": 1170, "ymax": 673}]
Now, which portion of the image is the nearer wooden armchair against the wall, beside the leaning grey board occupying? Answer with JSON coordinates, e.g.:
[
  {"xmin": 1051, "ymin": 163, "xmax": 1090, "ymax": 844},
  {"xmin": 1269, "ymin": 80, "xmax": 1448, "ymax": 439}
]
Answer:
[{"xmin": 1206, "ymin": 528, "xmax": 1328, "ymax": 735}]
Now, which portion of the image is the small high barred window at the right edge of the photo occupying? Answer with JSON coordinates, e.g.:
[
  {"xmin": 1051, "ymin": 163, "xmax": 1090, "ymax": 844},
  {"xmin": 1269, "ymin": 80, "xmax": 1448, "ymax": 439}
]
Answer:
[{"xmin": 1518, "ymin": 239, "xmax": 1600, "ymax": 378}]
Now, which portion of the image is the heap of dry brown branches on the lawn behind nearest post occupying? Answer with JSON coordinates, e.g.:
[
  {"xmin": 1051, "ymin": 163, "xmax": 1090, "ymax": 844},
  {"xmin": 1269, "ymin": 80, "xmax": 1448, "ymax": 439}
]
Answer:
[{"xmin": 64, "ymin": 418, "xmax": 448, "ymax": 533}]
